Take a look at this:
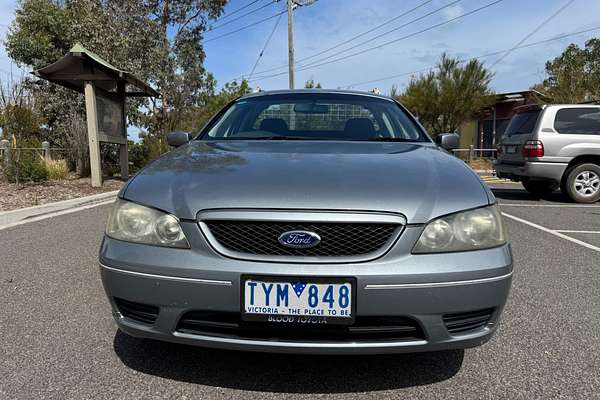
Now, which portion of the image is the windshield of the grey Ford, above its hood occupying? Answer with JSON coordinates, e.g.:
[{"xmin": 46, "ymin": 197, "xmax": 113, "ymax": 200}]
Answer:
[{"xmin": 199, "ymin": 93, "xmax": 429, "ymax": 142}]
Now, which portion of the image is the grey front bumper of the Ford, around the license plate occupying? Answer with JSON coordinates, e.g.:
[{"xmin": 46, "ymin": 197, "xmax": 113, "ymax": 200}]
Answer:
[{"xmin": 100, "ymin": 228, "xmax": 512, "ymax": 354}]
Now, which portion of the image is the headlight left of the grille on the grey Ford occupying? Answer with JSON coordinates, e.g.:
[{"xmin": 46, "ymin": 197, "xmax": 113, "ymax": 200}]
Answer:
[{"xmin": 106, "ymin": 199, "xmax": 190, "ymax": 249}]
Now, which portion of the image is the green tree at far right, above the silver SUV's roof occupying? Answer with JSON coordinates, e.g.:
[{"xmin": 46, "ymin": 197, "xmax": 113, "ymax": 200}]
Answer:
[{"xmin": 533, "ymin": 39, "xmax": 600, "ymax": 103}]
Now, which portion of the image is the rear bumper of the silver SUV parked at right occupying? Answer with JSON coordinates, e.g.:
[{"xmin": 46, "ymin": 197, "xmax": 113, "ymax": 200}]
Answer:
[{"xmin": 494, "ymin": 161, "xmax": 568, "ymax": 184}]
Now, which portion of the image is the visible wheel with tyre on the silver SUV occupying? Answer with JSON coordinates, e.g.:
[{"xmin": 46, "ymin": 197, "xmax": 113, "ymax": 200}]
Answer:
[{"xmin": 563, "ymin": 163, "xmax": 600, "ymax": 203}]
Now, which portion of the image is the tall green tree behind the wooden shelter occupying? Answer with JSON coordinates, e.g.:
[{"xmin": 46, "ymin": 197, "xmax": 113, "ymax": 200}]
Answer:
[{"xmin": 5, "ymin": 0, "xmax": 226, "ymax": 170}]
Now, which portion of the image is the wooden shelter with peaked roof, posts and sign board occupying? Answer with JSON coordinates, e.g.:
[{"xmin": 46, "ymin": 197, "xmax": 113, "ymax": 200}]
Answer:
[{"xmin": 33, "ymin": 44, "xmax": 160, "ymax": 187}]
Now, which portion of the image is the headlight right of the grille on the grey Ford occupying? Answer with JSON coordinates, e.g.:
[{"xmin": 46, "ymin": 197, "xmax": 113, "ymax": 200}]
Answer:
[{"xmin": 413, "ymin": 205, "xmax": 506, "ymax": 254}]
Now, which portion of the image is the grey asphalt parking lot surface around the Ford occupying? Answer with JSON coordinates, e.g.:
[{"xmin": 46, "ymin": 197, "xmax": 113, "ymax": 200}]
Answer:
[{"xmin": 0, "ymin": 184, "xmax": 600, "ymax": 399}]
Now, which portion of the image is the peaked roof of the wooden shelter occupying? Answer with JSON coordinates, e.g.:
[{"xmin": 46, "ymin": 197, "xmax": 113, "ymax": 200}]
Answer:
[{"xmin": 33, "ymin": 43, "xmax": 160, "ymax": 97}]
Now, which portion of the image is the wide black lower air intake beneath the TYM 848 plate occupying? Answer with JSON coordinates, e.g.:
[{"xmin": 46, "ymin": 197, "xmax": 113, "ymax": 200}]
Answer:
[{"xmin": 177, "ymin": 311, "xmax": 425, "ymax": 342}]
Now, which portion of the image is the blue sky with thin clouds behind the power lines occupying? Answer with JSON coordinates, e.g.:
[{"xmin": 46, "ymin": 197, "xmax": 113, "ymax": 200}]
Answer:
[{"xmin": 0, "ymin": 0, "xmax": 600, "ymax": 92}]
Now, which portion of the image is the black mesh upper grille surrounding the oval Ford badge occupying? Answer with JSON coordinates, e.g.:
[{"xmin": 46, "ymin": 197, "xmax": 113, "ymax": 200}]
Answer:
[{"xmin": 205, "ymin": 220, "xmax": 401, "ymax": 257}]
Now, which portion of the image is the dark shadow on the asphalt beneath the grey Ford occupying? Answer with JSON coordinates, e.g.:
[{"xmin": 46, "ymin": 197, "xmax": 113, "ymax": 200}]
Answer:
[{"xmin": 114, "ymin": 330, "xmax": 464, "ymax": 394}]
